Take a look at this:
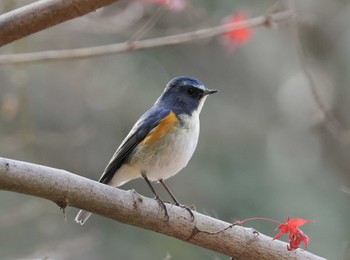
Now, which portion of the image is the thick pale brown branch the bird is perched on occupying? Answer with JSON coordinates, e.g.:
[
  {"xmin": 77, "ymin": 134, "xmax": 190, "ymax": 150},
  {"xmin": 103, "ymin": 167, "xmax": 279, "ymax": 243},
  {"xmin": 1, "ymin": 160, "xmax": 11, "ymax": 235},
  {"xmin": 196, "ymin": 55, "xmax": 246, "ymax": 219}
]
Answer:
[{"xmin": 0, "ymin": 158, "xmax": 323, "ymax": 260}]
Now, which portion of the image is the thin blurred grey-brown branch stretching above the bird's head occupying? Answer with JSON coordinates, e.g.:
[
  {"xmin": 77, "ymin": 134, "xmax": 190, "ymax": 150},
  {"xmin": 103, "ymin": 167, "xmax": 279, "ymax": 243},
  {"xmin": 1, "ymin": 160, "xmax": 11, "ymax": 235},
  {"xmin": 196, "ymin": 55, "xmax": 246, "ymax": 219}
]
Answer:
[{"xmin": 0, "ymin": 10, "xmax": 295, "ymax": 64}]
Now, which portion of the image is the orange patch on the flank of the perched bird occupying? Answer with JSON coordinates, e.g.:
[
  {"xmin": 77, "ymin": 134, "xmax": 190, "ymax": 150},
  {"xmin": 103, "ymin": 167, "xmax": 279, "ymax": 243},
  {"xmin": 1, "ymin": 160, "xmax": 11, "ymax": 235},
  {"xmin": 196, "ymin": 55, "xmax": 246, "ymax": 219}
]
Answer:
[{"xmin": 142, "ymin": 112, "xmax": 179, "ymax": 144}]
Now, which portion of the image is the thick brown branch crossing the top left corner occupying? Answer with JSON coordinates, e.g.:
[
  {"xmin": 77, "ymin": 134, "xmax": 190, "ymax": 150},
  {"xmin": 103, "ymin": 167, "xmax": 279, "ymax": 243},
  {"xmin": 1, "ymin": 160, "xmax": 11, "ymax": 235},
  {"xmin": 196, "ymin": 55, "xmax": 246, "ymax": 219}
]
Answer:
[{"xmin": 0, "ymin": 0, "xmax": 118, "ymax": 47}]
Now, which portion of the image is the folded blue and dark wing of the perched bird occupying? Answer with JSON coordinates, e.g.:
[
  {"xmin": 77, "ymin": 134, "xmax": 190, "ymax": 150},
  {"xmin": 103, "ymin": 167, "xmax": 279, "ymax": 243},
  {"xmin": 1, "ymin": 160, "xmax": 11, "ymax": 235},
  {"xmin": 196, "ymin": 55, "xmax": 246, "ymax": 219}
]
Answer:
[{"xmin": 99, "ymin": 107, "xmax": 173, "ymax": 184}]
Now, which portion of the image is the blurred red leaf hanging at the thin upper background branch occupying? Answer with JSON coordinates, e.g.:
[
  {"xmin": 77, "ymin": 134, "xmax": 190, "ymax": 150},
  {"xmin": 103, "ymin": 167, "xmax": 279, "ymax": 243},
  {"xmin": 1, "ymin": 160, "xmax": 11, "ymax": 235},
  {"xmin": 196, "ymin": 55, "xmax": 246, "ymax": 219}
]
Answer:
[{"xmin": 223, "ymin": 11, "xmax": 252, "ymax": 52}]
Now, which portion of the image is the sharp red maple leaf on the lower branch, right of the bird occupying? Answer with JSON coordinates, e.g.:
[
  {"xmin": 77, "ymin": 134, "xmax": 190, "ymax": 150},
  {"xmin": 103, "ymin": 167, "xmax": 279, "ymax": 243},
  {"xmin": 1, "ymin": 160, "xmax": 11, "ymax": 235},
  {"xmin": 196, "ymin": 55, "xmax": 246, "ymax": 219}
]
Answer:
[{"xmin": 273, "ymin": 216, "xmax": 314, "ymax": 251}]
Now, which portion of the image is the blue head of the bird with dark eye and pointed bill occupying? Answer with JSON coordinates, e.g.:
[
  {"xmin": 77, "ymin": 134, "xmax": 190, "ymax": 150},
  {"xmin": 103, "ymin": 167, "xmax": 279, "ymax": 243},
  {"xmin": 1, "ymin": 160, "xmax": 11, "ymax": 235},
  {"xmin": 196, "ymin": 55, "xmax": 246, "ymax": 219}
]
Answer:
[{"xmin": 156, "ymin": 77, "xmax": 218, "ymax": 115}]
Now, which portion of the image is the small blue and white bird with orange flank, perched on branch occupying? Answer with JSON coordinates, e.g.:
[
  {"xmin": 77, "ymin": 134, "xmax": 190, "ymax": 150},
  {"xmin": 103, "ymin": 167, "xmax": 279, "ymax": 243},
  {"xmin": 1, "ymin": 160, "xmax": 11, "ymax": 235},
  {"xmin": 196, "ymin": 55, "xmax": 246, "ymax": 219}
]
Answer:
[{"xmin": 75, "ymin": 76, "xmax": 218, "ymax": 225}]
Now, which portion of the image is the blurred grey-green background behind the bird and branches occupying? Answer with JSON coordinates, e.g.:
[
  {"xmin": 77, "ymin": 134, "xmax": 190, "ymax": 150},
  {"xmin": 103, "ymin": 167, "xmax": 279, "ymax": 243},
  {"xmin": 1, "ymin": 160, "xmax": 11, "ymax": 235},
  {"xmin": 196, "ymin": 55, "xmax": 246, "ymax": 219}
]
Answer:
[{"xmin": 0, "ymin": 0, "xmax": 350, "ymax": 259}]
